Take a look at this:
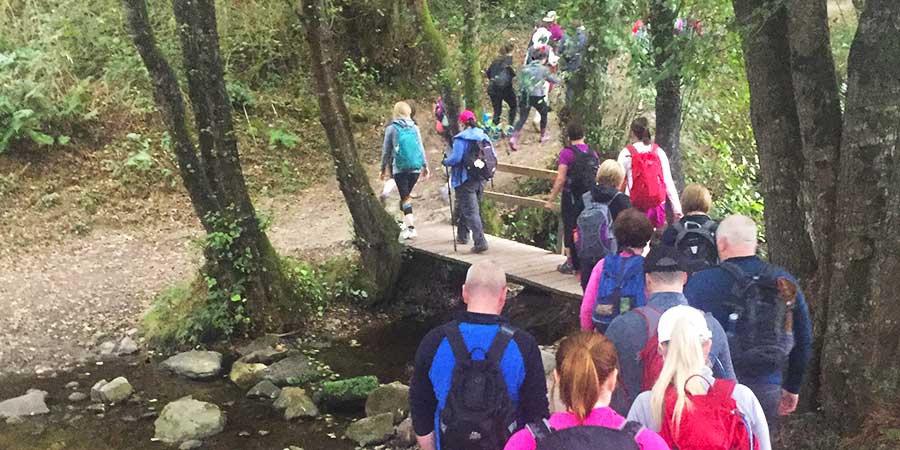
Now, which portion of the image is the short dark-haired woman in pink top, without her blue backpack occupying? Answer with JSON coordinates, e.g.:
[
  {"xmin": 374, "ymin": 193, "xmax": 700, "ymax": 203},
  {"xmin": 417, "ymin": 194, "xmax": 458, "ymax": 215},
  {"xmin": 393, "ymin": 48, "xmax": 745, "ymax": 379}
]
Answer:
[{"xmin": 578, "ymin": 208, "xmax": 653, "ymax": 330}]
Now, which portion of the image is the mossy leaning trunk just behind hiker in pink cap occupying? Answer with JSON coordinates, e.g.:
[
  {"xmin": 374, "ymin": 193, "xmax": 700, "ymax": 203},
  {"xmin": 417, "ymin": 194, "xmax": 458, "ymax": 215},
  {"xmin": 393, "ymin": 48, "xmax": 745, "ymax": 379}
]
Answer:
[{"xmin": 412, "ymin": 0, "xmax": 459, "ymax": 136}]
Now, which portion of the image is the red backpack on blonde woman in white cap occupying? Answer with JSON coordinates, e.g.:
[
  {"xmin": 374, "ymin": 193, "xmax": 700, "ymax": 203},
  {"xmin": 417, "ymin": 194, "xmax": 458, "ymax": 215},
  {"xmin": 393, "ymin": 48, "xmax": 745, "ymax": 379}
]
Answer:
[{"xmin": 659, "ymin": 380, "xmax": 759, "ymax": 450}]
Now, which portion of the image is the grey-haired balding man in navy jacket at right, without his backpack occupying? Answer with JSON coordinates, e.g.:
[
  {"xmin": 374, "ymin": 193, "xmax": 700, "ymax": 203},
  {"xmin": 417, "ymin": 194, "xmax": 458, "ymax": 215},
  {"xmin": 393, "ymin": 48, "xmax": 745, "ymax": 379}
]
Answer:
[{"xmin": 684, "ymin": 215, "xmax": 812, "ymax": 429}]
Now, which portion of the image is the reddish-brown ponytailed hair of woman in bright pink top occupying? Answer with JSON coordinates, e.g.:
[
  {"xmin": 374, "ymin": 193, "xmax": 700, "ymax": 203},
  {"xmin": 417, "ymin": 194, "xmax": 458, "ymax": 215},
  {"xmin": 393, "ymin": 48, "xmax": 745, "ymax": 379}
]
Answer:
[{"xmin": 556, "ymin": 331, "xmax": 619, "ymax": 422}]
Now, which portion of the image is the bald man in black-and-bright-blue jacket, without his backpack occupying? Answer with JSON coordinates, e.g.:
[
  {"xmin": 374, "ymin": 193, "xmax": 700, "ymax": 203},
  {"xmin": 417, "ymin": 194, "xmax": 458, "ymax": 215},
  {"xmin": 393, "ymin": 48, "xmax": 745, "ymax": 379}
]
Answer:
[{"xmin": 409, "ymin": 261, "xmax": 549, "ymax": 450}]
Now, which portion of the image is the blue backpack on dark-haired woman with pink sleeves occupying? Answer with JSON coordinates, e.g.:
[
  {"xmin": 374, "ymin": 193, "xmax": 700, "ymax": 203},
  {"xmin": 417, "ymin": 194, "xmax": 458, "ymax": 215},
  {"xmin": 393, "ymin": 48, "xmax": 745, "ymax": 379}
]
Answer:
[{"xmin": 591, "ymin": 255, "xmax": 647, "ymax": 333}]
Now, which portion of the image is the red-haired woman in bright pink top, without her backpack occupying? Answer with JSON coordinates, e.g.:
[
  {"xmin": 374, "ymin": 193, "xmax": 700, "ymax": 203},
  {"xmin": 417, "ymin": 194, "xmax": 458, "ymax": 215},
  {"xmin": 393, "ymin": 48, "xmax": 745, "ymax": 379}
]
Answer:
[{"xmin": 504, "ymin": 331, "xmax": 669, "ymax": 450}]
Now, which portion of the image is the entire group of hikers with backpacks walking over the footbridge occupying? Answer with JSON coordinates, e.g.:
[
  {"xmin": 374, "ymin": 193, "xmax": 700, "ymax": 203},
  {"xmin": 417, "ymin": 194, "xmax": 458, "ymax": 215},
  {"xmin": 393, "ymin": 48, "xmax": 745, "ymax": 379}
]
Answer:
[{"xmin": 374, "ymin": 11, "xmax": 812, "ymax": 450}]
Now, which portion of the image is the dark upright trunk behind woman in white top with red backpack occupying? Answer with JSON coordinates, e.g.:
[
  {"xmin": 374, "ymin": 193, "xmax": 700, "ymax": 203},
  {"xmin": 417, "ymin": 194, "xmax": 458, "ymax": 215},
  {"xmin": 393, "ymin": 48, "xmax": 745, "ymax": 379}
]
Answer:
[{"xmin": 648, "ymin": 0, "xmax": 684, "ymax": 191}]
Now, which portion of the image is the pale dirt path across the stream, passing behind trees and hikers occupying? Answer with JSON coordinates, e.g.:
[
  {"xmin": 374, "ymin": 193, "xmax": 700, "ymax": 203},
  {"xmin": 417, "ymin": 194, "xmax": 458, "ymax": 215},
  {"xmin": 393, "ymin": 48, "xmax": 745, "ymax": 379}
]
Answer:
[{"xmin": 0, "ymin": 101, "xmax": 557, "ymax": 375}]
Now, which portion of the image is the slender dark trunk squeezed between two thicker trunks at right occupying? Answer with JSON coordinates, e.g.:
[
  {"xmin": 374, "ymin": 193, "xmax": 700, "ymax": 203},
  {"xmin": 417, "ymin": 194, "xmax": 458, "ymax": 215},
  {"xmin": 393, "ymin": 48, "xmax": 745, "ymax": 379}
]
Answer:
[{"xmin": 788, "ymin": 0, "xmax": 842, "ymax": 409}]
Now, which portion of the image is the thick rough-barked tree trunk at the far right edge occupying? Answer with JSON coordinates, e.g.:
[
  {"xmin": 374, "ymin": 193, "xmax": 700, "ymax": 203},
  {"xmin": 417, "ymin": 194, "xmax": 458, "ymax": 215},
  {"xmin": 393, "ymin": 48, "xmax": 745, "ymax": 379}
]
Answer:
[{"xmin": 821, "ymin": 0, "xmax": 900, "ymax": 431}]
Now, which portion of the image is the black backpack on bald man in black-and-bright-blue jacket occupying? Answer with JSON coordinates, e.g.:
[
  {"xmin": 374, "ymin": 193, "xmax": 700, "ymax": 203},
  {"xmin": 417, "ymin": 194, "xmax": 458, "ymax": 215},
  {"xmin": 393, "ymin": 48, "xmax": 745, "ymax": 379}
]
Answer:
[{"xmin": 440, "ymin": 322, "xmax": 516, "ymax": 450}]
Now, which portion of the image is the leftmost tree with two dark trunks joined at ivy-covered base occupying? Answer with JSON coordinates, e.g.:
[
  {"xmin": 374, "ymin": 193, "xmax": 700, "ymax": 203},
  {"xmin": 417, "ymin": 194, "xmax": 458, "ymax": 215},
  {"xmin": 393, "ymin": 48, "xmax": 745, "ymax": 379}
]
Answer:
[{"xmin": 123, "ymin": 0, "xmax": 290, "ymax": 331}]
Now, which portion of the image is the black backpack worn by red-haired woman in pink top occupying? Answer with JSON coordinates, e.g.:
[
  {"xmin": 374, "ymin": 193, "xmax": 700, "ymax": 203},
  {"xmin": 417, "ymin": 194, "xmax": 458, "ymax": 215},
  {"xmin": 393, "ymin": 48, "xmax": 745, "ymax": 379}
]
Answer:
[{"xmin": 527, "ymin": 419, "xmax": 644, "ymax": 450}]
